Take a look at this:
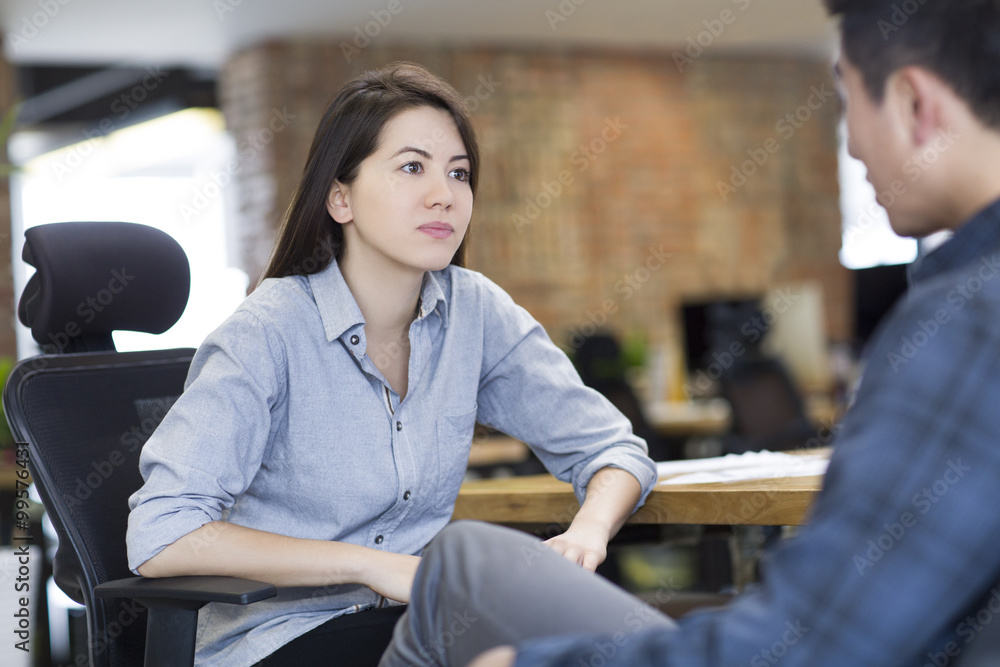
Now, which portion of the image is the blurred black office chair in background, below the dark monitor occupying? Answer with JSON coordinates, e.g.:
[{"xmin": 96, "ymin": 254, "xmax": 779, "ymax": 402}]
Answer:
[{"xmin": 719, "ymin": 357, "xmax": 817, "ymax": 454}]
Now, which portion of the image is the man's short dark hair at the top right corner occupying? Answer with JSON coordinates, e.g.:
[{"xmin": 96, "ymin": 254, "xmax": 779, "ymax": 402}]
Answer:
[{"xmin": 824, "ymin": 0, "xmax": 1000, "ymax": 128}]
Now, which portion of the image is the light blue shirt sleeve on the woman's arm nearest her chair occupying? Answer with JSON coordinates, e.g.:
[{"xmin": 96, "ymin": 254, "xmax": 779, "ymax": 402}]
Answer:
[{"xmin": 126, "ymin": 310, "xmax": 285, "ymax": 572}]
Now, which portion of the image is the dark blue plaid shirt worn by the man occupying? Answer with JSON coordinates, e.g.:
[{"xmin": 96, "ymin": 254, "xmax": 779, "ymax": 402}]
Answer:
[{"xmin": 516, "ymin": 196, "xmax": 1000, "ymax": 667}]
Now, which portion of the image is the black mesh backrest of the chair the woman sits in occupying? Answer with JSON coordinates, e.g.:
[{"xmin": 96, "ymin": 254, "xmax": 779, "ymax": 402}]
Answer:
[{"xmin": 4, "ymin": 349, "xmax": 194, "ymax": 666}]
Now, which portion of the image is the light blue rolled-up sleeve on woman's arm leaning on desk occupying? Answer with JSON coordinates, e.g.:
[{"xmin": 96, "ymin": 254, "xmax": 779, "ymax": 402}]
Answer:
[{"xmin": 478, "ymin": 280, "xmax": 656, "ymax": 508}]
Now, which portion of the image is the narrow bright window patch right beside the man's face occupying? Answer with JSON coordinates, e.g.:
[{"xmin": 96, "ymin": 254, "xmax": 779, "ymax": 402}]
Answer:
[{"xmin": 838, "ymin": 122, "xmax": 917, "ymax": 269}]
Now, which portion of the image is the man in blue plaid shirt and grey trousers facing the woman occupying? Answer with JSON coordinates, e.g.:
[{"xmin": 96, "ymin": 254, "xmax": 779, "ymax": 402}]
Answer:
[{"xmin": 382, "ymin": 0, "xmax": 1000, "ymax": 667}]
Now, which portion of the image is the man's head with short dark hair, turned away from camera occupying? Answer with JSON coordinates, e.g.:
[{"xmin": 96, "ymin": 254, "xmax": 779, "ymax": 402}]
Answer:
[{"xmin": 825, "ymin": 0, "xmax": 1000, "ymax": 236}]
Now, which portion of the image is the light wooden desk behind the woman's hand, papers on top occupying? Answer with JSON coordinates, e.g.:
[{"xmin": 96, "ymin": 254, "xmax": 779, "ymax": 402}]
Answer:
[{"xmin": 452, "ymin": 454, "xmax": 823, "ymax": 526}]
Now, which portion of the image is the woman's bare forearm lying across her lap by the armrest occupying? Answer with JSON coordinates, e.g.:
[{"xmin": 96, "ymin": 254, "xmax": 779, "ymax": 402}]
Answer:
[{"xmin": 138, "ymin": 521, "xmax": 420, "ymax": 602}]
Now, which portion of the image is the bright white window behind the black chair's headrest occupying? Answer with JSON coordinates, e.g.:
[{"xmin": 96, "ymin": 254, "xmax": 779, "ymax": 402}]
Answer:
[{"xmin": 10, "ymin": 109, "xmax": 248, "ymax": 357}]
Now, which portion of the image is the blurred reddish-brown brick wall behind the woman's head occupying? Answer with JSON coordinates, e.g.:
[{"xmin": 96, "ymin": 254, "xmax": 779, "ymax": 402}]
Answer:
[{"xmin": 220, "ymin": 40, "xmax": 851, "ymax": 366}]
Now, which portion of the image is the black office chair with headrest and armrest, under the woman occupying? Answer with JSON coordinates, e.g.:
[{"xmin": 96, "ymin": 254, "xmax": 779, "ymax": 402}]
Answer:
[{"xmin": 3, "ymin": 222, "xmax": 276, "ymax": 667}]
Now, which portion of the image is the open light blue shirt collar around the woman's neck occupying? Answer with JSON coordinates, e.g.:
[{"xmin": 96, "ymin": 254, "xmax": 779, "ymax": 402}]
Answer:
[{"xmin": 309, "ymin": 260, "xmax": 448, "ymax": 341}]
